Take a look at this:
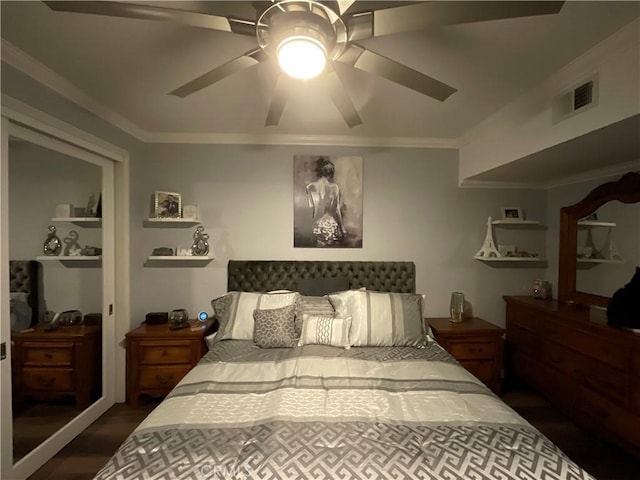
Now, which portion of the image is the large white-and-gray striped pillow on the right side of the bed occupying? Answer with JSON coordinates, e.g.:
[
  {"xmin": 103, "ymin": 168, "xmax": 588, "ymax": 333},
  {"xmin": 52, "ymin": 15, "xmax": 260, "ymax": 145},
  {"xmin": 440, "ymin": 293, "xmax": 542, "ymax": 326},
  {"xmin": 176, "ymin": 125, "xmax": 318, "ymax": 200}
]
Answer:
[{"xmin": 329, "ymin": 290, "xmax": 427, "ymax": 347}]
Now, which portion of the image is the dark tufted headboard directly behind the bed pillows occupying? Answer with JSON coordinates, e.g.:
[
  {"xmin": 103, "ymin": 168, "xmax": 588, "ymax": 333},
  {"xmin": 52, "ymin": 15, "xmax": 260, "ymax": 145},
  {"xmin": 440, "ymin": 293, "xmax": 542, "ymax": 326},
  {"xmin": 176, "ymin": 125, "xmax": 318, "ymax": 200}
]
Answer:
[{"xmin": 227, "ymin": 260, "xmax": 416, "ymax": 293}]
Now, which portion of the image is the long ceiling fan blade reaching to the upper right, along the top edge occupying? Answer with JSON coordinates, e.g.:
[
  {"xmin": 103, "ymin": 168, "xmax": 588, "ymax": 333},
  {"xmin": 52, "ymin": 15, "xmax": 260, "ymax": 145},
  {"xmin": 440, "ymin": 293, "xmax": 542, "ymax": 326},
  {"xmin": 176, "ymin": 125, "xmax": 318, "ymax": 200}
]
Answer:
[{"xmin": 345, "ymin": 1, "xmax": 564, "ymax": 41}]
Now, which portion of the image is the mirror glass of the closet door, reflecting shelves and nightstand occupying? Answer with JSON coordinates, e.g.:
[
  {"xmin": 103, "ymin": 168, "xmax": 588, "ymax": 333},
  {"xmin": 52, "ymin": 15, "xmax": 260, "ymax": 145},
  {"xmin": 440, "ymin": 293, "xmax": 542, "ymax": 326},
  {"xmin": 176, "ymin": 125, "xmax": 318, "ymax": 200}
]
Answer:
[{"xmin": 9, "ymin": 138, "xmax": 102, "ymax": 462}]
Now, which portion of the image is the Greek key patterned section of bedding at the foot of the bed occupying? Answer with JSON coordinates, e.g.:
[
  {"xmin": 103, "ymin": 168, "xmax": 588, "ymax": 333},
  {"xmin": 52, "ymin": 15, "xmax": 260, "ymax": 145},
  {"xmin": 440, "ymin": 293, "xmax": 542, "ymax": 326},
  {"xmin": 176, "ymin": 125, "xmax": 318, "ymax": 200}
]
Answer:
[{"xmin": 97, "ymin": 422, "xmax": 590, "ymax": 480}]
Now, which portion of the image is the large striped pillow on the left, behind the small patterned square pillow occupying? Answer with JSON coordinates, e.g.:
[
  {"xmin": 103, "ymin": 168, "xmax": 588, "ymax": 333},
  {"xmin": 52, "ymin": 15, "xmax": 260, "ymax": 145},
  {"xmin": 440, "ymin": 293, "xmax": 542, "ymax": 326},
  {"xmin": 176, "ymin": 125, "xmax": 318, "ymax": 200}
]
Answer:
[{"xmin": 211, "ymin": 292, "xmax": 298, "ymax": 342}]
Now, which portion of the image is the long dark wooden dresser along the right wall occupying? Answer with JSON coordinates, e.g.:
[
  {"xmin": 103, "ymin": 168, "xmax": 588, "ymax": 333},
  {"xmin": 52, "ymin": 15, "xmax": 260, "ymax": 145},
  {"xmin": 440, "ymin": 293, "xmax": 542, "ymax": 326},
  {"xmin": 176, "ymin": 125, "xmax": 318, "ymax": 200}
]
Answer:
[{"xmin": 504, "ymin": 297, "xmax": 640, "ymax": 458}]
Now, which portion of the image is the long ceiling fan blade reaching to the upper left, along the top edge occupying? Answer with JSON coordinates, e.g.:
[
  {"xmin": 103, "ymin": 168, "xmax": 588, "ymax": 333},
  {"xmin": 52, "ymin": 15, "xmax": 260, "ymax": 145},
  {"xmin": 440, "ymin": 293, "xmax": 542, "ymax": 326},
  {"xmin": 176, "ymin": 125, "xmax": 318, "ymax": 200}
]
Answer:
[{"xmin": 44, "ymin": 1, "xmax": 256, "ymax": 35}]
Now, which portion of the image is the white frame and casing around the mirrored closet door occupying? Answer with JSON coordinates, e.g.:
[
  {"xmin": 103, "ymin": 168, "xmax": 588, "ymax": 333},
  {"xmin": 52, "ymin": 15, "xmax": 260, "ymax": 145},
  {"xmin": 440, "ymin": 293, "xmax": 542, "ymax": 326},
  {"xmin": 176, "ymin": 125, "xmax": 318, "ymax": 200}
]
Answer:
[{"xmin": 0, "ymin": 95, "xmax": 129, "ymax": 480}]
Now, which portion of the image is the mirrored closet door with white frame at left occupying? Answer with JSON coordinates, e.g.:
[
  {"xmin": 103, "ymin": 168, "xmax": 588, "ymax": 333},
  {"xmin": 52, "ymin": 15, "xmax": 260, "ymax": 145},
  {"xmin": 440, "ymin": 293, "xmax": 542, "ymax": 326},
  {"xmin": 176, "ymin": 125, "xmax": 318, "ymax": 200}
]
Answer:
[{"xmin": 2, "ymin": 117, "xmax": 114, "ymax": 478}]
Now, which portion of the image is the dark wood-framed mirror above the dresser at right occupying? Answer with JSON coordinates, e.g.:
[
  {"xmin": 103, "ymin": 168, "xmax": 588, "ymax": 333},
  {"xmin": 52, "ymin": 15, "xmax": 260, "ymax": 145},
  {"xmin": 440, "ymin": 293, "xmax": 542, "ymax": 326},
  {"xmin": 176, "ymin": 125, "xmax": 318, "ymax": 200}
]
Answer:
[{"xmin": 558, "ymin": 172, "xmax": 640, "ymax": 307}]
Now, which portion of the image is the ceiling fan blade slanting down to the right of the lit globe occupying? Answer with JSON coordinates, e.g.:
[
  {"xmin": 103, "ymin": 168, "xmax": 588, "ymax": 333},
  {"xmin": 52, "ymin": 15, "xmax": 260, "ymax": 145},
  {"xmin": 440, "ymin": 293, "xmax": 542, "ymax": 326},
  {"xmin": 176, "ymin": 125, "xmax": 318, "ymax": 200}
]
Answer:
[{"xmin": 338, "ymin": 44, "xmax": 457, "ymax": 102}]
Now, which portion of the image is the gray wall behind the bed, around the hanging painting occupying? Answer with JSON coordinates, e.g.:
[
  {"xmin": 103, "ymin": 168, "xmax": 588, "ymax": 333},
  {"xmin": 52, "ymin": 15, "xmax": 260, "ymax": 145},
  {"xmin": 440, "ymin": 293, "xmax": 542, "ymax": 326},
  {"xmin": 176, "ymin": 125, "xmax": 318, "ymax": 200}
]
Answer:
[{"xmin": 131, "ymin": 144, "xmax": 545, "ymax": 325}]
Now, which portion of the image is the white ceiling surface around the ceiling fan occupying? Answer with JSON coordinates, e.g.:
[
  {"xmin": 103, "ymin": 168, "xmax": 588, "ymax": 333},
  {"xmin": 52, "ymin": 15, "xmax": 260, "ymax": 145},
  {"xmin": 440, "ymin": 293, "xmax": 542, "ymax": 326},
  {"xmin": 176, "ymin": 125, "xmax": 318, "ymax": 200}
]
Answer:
[{"xmin": 1, "ymin": 0, "xmax": 640, "ymax": 184}]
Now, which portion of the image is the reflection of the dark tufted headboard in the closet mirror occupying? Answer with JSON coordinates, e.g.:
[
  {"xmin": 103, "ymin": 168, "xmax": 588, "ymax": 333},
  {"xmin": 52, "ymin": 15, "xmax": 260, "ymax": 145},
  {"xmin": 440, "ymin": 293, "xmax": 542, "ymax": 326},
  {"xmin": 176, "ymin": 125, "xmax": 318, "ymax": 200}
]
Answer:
[{"xmin": 9, "ymin": 260, "xmax": 47, "ymax": 327}]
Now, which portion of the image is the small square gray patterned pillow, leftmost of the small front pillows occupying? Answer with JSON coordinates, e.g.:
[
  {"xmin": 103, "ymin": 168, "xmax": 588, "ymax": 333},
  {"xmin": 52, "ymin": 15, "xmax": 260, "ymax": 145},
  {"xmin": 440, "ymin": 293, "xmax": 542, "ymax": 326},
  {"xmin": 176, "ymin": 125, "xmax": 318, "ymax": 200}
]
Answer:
[{"xmin": 253, "ymin": 305, "xmax": 298, "ymax": 348}]
